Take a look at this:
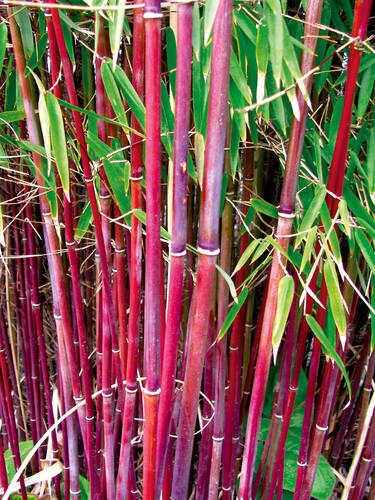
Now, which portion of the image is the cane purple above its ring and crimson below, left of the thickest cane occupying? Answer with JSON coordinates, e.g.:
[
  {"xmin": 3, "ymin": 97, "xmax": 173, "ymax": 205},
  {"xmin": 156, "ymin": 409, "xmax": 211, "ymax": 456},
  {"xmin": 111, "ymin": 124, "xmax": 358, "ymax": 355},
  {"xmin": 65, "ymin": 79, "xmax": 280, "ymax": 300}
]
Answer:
[{"xmin": 156, "ymin": 4, "xmax": 193, "ymax": 496}]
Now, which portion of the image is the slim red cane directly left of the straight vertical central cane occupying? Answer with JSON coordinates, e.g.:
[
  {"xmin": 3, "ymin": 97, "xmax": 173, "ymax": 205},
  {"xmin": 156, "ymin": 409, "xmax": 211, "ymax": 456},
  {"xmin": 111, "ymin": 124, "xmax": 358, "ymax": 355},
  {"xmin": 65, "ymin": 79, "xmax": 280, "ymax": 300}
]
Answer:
[{"xmin": 116, "ymin": 1, "xmax": 144, "ymax": 494}]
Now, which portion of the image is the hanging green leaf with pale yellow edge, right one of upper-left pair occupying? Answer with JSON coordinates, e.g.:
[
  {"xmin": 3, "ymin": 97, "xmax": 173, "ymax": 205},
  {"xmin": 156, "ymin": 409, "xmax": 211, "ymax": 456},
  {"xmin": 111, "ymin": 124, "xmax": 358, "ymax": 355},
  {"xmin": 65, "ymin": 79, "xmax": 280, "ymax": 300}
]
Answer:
[{"xmin": 46, "ymin": 92, "xmax": 70, "ymax": 200}]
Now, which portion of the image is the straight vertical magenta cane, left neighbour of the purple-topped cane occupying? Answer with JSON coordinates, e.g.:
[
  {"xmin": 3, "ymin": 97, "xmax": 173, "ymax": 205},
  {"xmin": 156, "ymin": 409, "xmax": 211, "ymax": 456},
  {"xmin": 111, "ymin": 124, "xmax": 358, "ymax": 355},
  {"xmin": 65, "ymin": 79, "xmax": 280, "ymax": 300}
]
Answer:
[{"xmin": 143, "ymin": 0, "xmax": 162, "ymax": 500}]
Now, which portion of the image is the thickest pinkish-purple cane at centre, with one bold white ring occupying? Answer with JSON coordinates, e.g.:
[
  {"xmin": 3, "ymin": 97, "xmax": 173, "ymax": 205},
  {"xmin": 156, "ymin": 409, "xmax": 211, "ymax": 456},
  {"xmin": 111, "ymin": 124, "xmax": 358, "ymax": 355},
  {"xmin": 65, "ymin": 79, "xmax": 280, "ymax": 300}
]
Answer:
[{"xmin": 171, "ymin": 0, "xmax": 232, "ymax": 500}]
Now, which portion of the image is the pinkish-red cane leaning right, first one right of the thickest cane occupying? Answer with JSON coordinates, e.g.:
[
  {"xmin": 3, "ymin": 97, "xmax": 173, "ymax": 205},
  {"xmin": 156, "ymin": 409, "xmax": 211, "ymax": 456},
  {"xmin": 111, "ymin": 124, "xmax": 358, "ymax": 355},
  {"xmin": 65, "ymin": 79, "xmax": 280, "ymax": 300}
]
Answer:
[{"xmin": 238, "ymin": 0, "xmax": 323, "ymax": 500}]
